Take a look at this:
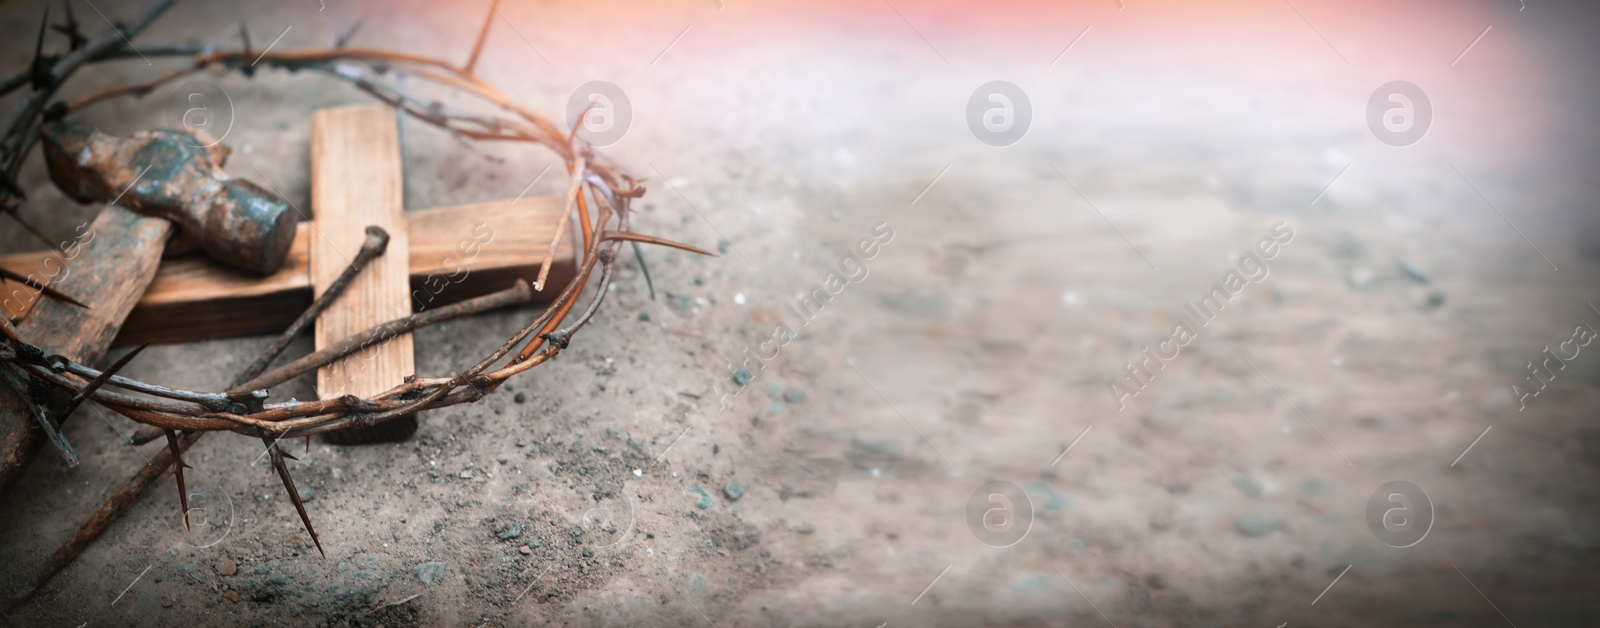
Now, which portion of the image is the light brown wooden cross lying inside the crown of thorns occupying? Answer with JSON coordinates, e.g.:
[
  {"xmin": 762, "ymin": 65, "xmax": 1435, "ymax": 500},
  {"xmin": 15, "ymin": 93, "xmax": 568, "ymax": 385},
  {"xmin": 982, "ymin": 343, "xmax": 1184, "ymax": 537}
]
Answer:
[{"xmin": 0, "ymin": 104, "xmax": 576, "ymax": 442}]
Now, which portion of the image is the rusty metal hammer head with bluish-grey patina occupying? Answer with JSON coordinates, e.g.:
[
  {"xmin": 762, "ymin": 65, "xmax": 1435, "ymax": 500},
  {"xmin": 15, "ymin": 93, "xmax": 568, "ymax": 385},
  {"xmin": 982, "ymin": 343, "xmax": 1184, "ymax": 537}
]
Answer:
[{"xmin": 43, "ymin": 122, "xmax": 296, "ymax": 274}]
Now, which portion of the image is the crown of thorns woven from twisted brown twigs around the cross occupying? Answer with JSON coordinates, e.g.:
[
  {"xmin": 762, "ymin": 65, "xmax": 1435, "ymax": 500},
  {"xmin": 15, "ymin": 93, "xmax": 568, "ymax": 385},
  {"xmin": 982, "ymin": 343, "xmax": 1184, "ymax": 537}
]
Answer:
[{"xmin": 0, "ymin": 0, "xmax": 712, "ymax": 563}]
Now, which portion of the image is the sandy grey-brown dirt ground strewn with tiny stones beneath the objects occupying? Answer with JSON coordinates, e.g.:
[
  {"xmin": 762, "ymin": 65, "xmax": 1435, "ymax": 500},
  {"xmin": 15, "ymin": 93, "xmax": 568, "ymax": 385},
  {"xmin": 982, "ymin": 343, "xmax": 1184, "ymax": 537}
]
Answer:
[{"xmin": 0, "ymin": 0, "xmax": 1600, "ymax": 628}]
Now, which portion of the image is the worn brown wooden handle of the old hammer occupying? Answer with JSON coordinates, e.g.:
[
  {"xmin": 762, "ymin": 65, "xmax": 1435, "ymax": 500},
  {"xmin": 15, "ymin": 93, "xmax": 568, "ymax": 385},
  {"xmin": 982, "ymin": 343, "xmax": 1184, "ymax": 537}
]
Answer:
[{"xmin": 0, "ymin": 205, "xmax": 173, "ymax": 490}]
